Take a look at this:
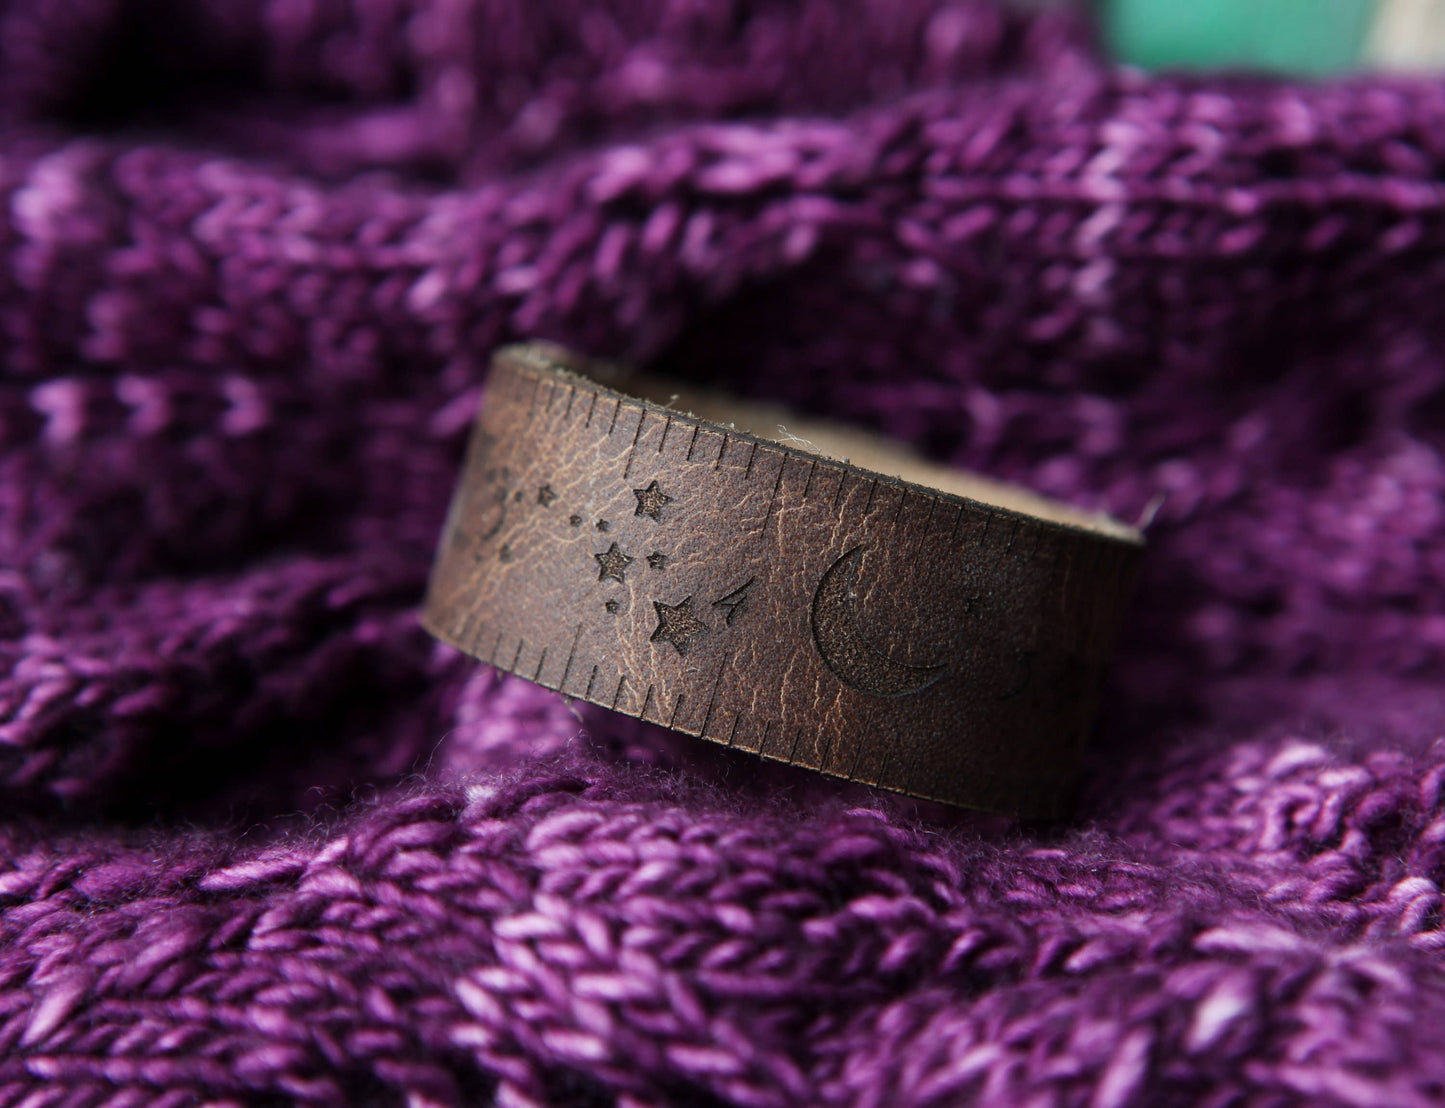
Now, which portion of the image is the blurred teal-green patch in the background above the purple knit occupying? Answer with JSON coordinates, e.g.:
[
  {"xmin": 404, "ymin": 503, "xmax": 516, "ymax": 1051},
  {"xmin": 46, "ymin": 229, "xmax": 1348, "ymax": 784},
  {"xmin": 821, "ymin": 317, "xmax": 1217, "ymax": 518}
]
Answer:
[{"xmin": 1104, "ymin": 0, "xmax": 1376, "ymax": 77}]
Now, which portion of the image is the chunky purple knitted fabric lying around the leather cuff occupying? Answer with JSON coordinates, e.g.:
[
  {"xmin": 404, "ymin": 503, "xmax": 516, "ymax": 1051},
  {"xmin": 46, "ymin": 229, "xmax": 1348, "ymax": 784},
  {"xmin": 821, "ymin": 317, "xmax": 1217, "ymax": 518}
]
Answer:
[{"xmin": 0, "ymin": 0, "xmax": 1445, "ymax": 1108}]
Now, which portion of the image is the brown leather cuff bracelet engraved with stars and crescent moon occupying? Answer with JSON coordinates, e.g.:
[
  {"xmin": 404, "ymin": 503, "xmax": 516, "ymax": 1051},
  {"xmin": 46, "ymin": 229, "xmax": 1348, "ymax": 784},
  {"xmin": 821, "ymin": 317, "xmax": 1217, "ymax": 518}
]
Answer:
[{"xmin": 423, "ymin": 344, "xmax": 1142, "ymax": 818}]
